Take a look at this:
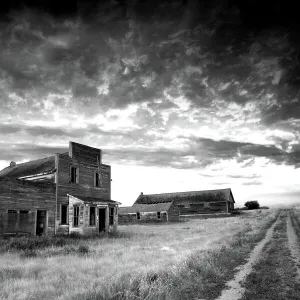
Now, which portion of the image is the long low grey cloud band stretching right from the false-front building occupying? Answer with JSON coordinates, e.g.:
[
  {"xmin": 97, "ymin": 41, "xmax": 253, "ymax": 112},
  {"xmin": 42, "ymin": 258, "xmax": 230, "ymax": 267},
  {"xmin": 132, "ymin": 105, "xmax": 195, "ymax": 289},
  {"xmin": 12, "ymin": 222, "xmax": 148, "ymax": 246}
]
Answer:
[{"xmin": 105, "ymin": 138, "xmax": 300, "ymax": 169}]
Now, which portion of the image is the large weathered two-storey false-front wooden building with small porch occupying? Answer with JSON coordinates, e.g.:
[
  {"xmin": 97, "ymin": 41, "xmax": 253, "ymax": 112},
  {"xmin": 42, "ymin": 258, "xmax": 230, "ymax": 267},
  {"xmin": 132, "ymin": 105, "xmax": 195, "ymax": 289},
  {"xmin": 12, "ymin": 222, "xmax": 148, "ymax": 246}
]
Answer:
[{"xmin": 0, "ymin": 142, "xmax": 120, "ymax": 235}]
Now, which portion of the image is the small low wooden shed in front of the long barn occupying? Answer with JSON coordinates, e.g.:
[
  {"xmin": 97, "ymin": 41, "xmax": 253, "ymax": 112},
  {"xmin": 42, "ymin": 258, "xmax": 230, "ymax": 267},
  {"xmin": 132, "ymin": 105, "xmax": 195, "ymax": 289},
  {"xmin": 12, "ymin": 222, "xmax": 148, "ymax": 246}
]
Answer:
[{"xmin": 118, "ymin": 201, "xmax": 179, "ymax": 225}]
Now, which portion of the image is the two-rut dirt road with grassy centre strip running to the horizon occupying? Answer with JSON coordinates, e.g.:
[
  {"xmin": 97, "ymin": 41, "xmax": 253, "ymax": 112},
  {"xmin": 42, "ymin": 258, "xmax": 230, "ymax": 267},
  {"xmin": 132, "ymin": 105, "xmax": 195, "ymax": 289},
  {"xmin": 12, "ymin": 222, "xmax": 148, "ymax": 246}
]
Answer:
[{"xmin": 217, "ymin": 210, "xmax": 300, "ymax": 300}]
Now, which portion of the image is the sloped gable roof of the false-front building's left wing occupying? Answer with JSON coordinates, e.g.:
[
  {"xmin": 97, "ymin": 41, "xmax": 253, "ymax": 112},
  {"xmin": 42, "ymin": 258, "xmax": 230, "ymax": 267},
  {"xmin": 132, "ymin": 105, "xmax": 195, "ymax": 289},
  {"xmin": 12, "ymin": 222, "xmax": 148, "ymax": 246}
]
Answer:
[{"xmin": 0, "ymin": 156, "xmax": 55, "ymax": 178}]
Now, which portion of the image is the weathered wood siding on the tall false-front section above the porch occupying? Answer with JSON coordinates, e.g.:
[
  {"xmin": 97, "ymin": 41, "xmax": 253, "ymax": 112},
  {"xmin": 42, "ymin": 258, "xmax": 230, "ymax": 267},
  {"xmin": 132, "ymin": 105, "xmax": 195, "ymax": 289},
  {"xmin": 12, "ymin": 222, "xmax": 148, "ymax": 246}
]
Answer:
[{"xmin": 56, "ymin": 149, "xmax": 112, "ymax": 234}]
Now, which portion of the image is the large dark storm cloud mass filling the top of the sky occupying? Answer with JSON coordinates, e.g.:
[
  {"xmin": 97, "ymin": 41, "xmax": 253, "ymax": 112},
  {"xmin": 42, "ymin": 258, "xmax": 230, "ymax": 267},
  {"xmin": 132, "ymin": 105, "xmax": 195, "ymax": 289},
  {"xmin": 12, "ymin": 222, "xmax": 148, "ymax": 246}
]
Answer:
[{"xmin": 0, "ymin": 0, "xmax": 299, "ymax": 119}]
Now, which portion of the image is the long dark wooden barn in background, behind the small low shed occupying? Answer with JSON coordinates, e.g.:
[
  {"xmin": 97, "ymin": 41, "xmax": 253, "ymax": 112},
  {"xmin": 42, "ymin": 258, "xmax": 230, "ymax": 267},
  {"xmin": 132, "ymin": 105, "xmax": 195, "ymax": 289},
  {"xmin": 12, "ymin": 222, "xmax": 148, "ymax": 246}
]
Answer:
[{"xmin": 133, "ymin": 188, "xmax": 235, "ymax": 216}]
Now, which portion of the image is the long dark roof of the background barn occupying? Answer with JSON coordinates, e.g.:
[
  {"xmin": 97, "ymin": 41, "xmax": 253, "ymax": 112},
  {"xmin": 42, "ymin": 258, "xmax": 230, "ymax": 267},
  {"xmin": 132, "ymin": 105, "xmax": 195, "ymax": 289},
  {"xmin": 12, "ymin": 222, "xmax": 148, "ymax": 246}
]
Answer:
[{"xmin": 134, "ymin": 188, "xmax": 235, "ymax": 204}]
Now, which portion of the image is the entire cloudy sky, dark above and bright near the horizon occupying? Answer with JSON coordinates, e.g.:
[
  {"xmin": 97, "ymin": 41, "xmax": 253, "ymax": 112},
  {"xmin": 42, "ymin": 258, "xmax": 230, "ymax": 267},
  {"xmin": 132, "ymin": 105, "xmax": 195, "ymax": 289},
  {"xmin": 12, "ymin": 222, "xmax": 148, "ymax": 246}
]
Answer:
[{"xmin": 0, "ymin": 0, "xmax": 300, "ymax": 207}]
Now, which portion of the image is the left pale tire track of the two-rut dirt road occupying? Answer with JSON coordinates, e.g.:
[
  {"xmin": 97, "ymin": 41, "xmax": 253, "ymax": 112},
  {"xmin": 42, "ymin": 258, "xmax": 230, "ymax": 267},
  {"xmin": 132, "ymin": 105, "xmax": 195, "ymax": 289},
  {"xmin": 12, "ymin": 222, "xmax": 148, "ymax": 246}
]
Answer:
[{"xmin": 216, "ymin": 212, "xmax": 281, "ymax": 300}]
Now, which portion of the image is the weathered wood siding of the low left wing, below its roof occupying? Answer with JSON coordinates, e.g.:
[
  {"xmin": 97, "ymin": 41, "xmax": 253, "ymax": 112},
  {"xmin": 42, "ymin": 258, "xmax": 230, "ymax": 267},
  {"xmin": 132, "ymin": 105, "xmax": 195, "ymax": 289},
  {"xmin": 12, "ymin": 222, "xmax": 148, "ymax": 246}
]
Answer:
[{"xmin": 0, "ymin": 179, "xmax": 55, "ymax": 235}]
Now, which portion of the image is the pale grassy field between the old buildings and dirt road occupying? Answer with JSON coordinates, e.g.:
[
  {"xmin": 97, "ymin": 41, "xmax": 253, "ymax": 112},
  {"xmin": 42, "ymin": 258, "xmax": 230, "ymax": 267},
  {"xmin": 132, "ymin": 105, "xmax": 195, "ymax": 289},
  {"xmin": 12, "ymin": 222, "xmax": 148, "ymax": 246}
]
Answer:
[{"xmin": 0, "ymin": 210, "xmax": 278, "ymax": 300}]
